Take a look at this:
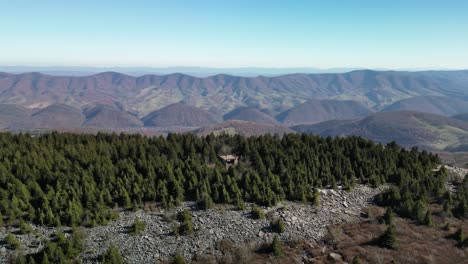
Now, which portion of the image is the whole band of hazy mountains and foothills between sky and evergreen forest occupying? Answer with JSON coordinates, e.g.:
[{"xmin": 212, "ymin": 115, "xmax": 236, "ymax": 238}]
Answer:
[{"xmin": 0, "ymin": 70, "xmax": 468, "ymax": 150}]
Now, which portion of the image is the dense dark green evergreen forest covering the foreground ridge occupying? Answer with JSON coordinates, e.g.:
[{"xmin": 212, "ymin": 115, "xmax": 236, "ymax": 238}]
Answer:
[{"xmin": 0, "ymin": 133, "xmax": 468, "ymax": 229}]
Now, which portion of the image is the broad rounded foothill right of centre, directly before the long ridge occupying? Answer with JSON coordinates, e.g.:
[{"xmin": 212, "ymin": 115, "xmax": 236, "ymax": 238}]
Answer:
[{"xmin": 277, "ymin": 100, "xmax": 371, "ymax": 125}]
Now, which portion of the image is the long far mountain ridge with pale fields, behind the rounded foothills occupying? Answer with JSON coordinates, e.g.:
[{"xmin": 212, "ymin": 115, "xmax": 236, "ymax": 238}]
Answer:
[{"xmin": 0, "ymin": 70, "xmax": 468, "ymax": 116}]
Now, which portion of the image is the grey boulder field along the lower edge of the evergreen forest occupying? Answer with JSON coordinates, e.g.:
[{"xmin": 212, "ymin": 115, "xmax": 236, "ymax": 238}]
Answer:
[{"xmin": 0, "ymin": 186, "xmax": 382, "ymax": 263}]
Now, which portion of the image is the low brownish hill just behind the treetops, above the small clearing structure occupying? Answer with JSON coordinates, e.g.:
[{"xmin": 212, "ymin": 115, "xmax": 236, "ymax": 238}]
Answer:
[{"xmin": 194, "ymin": 120, "xmax": 294, "ymax": 136}]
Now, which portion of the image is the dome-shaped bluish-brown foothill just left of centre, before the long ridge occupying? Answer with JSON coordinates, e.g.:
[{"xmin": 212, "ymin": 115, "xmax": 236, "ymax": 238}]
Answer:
[{"xmin": 142, "ymin": 103, "xmax": 219, "ymax": 127}]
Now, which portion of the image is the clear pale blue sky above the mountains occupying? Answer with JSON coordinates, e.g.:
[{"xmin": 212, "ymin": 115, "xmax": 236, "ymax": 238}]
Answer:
[{"xmin": 0, "ymin": 0, "xmax": 468, "ymax": 69}]
